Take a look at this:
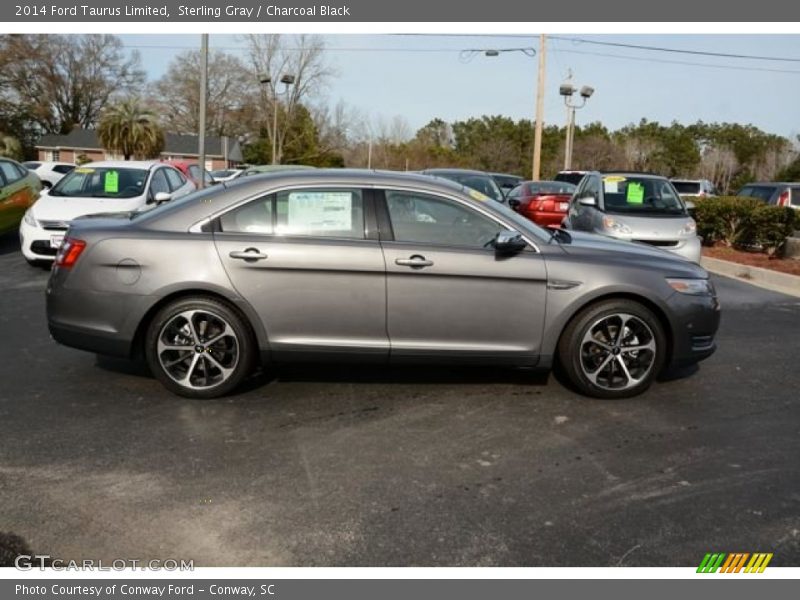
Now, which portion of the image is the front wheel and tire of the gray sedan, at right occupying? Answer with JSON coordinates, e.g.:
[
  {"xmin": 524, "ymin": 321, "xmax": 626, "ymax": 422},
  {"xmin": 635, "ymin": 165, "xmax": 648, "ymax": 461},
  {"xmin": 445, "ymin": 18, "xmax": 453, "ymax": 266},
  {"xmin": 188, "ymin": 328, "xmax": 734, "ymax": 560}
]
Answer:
[{"xmin": 558, "ymin": 299, "xmax": 667, "ymax": 399}]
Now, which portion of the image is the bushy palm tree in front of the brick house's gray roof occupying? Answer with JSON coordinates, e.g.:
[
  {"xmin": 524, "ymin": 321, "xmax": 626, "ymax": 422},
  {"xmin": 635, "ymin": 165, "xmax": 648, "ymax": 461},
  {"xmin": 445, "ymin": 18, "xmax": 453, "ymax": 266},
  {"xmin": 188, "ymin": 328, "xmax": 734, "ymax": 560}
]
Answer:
[{"xmin": 97, "ymin": 98, "xmax": 164, "ymax": 160}]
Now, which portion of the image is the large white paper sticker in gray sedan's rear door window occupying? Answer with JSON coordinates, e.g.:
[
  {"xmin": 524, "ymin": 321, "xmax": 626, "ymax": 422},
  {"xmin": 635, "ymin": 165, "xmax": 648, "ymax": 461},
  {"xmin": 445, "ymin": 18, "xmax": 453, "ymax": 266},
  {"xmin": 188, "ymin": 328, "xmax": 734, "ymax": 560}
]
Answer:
[{"xmin": 282, "ymin": 192, "xmax": 353, "ymax": 233}]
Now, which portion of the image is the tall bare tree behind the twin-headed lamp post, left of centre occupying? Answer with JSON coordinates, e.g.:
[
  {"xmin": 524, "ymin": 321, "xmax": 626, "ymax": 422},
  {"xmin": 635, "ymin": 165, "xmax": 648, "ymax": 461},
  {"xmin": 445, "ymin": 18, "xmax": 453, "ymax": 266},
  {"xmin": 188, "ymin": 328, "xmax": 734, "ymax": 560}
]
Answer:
[{"xmin": 246, "ymin": 34, "xmax": 333, "ymax": 162}]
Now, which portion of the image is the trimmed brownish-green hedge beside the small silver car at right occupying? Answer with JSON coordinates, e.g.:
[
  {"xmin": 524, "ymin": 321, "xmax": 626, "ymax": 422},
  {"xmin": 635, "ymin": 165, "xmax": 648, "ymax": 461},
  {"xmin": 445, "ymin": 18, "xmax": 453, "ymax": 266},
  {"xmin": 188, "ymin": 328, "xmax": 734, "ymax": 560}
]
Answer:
[{"xmin": 691, "ymin": 196, "xmax": 800, "ymax": 256}]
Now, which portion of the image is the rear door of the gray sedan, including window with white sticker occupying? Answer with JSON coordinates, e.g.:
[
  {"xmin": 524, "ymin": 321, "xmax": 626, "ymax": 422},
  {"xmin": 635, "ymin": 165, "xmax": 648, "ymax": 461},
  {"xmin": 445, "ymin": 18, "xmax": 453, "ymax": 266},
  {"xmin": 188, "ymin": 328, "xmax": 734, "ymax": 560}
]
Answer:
[{"xmin": 214, "ymin": 187, "xmax": 389, "ymax": 360}]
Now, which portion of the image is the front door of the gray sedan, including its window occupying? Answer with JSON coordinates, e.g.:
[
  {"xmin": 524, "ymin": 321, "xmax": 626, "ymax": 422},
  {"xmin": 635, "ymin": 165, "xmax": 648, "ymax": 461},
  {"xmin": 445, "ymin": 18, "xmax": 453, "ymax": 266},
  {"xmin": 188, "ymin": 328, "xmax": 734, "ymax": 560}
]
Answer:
[{"xmin": 377, "ymin": 189, "xmax": 547, "ymax": 364}]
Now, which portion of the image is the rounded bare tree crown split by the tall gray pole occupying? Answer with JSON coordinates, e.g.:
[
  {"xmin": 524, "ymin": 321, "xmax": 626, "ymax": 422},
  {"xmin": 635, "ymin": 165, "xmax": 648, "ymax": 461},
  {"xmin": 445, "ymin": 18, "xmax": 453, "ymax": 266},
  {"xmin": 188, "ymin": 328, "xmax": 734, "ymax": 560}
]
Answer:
[{"xmin": 151, "ymin": 50, "xmax": 252, "ymax": 136}]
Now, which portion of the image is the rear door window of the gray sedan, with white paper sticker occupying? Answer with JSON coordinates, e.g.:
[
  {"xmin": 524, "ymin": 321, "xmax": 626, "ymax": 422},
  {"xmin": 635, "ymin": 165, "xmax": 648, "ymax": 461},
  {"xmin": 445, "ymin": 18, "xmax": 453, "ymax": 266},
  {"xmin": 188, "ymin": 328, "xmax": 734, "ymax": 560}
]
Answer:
[{"xmin": 220, "ymin": 189, "xmax": 365, "ymax": 239}]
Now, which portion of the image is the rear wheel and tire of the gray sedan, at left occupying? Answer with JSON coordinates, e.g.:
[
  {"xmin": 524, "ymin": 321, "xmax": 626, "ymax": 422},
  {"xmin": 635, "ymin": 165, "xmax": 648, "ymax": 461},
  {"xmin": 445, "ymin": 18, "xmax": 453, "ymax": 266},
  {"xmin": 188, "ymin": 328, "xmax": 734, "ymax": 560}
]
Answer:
[{"xmin": 145, "ymin": 296, "xmax": 256, "ymax": 399}]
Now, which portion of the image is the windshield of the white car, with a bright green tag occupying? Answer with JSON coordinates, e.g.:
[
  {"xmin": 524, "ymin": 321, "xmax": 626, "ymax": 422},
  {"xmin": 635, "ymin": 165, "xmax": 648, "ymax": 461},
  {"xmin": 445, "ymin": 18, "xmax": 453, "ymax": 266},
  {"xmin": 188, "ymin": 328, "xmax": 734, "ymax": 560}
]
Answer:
[{"xmin": 50, "ymin": 167, "xmax": 148, "ymax": 198}]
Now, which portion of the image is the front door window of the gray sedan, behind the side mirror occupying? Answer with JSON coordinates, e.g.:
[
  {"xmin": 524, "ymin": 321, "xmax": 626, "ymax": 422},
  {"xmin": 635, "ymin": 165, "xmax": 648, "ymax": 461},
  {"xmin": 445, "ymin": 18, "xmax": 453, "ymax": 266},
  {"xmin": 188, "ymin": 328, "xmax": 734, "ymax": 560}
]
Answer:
[{"xmin": 386, "ymin": 190, "xmax": 505, "ymax": 248}]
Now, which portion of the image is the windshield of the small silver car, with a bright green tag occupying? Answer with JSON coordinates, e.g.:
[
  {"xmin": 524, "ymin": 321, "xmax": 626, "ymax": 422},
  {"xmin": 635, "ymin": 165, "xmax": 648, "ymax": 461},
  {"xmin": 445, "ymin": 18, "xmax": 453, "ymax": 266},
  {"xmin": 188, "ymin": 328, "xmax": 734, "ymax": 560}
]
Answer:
[{"xmin": 603, "ymin": 175, "xmax": 686, "ymax": 215}]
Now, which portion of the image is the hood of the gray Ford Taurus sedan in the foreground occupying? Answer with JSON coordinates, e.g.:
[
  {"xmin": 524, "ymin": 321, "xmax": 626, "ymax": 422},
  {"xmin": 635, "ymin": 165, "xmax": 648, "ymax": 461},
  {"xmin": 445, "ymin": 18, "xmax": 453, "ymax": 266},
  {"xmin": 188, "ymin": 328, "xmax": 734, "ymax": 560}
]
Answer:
[{"xmin": 558, "ymin": 230, "xmax": 706, "ymax": 277}]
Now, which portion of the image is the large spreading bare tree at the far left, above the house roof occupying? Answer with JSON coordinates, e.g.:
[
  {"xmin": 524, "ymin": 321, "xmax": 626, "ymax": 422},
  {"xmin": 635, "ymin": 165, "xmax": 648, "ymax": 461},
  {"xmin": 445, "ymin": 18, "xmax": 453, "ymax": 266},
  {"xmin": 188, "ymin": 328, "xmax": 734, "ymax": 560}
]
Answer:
[{"xmin": 0, "ymin": 34, "xmax": 145, "ymax": 134}]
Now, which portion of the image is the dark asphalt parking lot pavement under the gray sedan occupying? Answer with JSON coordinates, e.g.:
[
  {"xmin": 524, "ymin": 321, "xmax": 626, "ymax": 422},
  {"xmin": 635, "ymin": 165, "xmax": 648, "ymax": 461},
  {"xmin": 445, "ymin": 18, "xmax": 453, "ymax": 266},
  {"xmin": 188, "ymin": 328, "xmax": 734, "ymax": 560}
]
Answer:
[{"xmin": 0, "ymin": 231, "xmax": 800, "ymax": 566}]
